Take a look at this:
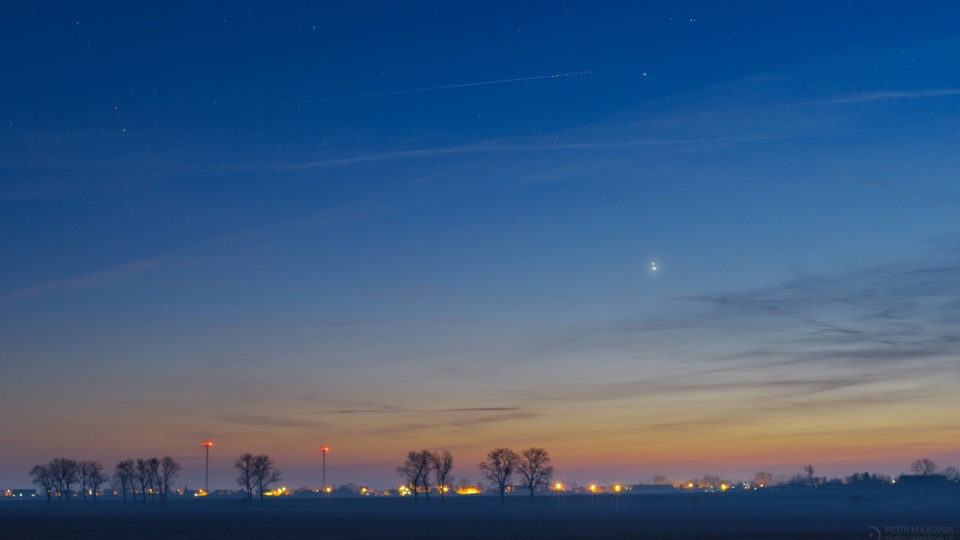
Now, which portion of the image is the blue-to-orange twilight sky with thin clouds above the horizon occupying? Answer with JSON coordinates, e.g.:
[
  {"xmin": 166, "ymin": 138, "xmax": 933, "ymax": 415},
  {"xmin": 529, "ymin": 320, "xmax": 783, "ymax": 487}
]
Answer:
[{"xmin": 0, "ymin": 0, "xmax": 960, "ymax": 487}]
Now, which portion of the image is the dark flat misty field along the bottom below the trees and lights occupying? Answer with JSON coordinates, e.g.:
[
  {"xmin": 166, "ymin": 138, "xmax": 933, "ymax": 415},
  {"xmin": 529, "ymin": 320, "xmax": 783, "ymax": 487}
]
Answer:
[{"xmin": 0, "ymin": 490, "xmax": 960, "ymax": 540}]
